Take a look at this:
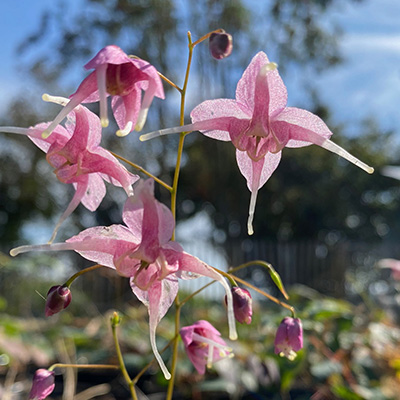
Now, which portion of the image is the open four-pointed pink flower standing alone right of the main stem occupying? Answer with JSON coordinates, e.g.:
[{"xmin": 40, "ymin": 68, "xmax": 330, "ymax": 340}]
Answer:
[{"xmin": 140, "ymin": 52, "xmax": 373, "ymax": 235}]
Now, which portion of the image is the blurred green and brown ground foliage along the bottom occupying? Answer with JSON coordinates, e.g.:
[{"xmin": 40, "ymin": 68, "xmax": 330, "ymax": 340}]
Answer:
[{"xmin": 0, "ymin": 262, "xmax": 400, "ymax": 400}]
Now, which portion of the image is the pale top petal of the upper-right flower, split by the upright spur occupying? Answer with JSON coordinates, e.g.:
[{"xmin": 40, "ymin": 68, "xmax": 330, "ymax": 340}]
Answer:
[{"xmin": 236, "ymin": 52, "xmax": 287, "ymax": 116}]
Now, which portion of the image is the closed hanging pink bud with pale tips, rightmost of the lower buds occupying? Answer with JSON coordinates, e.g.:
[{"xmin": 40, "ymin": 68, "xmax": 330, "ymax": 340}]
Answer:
[{"xmin": 274, "ymin": 317, "xmax": 303, "ymax": 361}]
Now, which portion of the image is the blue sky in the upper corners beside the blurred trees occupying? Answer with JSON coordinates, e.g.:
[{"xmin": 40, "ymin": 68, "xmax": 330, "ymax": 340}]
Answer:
[{"xmin": 0, "ymin": 0, "xmax": 400, "ymax": 138}]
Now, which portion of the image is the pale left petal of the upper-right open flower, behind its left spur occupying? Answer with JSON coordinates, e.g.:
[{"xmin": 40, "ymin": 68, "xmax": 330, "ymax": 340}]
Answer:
[{"xmin": 190, "ymin": 99, "xmax": 252, "ymax": 141}]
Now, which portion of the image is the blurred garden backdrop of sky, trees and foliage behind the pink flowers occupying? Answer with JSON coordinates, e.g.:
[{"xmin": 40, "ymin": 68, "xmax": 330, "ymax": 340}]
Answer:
[{"xmin": 0, "ymin": 0, "xmax": 400, "ymax": 399}]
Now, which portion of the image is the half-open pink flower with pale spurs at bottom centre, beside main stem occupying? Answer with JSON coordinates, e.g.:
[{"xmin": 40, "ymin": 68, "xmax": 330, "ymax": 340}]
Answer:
[{"xmin": 180, "ymin": 321, "xmax": 233, "ymax": 375}]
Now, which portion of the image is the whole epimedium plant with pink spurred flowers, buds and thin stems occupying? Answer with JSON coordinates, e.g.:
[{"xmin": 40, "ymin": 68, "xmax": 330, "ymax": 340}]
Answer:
[{"xmin": 0, "ymin": 29, "xmax": 373, "ymax": 400}]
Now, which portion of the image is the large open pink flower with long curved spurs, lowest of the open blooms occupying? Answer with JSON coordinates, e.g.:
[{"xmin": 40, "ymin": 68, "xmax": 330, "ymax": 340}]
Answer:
[{"xmin": 10, "ymin": 179, "xmax": 237, "ymax": 379}]
